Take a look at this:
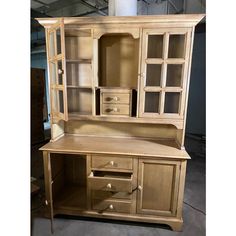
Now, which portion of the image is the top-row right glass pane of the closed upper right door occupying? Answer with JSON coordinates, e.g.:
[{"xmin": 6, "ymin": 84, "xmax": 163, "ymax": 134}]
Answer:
[{"xmin": 168, "ymin": 34, "xmax": 185, "ymax": 58}]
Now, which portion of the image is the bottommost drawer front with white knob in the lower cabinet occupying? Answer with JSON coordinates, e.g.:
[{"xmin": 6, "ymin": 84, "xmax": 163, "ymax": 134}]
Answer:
[{"xmin": 92, "ymin": 199, "xmax": 132, "ymax": 213}]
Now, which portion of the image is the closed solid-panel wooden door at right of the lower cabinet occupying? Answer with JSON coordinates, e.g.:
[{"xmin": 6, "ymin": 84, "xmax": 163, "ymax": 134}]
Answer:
[{"xmin": 137, "ymin": 159, "xmax": 180, "ymax": 216}]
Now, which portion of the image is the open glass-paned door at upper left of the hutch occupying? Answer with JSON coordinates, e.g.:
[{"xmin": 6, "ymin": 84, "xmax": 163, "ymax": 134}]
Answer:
[{"xmin": 46, "ymin": 19, "xmax": 68, "ymax": 120}]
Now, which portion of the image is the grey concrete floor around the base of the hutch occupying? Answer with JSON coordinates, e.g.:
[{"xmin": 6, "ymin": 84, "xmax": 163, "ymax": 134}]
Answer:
[{"xmin": 31, "ymin": 134, "xmax": 206, "ymax": 236}]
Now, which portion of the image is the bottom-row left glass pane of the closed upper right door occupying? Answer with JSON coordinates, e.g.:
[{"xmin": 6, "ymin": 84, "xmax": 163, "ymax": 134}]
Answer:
[{"xmin": 144, "ymin": 92, "xmax": 159, "ymax": 113}]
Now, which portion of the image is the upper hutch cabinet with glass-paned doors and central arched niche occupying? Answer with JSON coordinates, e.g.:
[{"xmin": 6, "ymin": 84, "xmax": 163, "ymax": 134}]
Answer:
[{"xmin": 40, "ymin": 15, "xmax": 205, "ymax": 134}]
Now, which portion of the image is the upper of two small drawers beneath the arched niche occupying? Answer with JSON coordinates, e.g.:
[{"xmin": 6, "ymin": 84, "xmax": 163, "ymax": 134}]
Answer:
[{"xmin": 102, "ymin": 93, "xmax": 130, "ymax": 104}]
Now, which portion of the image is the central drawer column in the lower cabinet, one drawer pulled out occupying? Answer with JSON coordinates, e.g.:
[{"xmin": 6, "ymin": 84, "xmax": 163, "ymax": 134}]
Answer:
[{"xmin": 88, "ymin": 155, "xmax": 137, "ymax": 213}]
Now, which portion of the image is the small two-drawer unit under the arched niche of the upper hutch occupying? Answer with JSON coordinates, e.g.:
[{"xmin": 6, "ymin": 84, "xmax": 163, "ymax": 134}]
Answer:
[{"xmin": 100, "ymin": 88, "xmax": 132, "ymax": 116}]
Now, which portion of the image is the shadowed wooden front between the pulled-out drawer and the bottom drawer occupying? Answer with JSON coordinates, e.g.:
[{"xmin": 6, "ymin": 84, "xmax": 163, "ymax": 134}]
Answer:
[{"xmin": 92, "ymin": 190, "xmax": 134, "ymax": 200}]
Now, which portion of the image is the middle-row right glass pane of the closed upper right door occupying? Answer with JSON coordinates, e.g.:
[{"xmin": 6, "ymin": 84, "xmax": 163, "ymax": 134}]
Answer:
[{"xmin": 166, "ymin": 64, "xmax": 182, "ymax": 87}]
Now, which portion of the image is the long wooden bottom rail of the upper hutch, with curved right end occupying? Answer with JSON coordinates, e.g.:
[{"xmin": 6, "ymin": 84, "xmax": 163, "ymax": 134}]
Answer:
[{"xmin": 69, "ymin": 112, "xmax": 184, "ymax": 129}]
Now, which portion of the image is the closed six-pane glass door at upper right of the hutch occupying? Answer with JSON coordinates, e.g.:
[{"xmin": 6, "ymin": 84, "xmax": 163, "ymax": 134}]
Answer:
[{"xmin": 139, "ymin": 28, "xmax": 191, "ymax": 118}]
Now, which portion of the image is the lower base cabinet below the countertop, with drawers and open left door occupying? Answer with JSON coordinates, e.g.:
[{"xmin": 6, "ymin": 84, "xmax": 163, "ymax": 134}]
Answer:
[{"xmin": 41, "ymin": 151, "xmax": 186, "ymax": 231}]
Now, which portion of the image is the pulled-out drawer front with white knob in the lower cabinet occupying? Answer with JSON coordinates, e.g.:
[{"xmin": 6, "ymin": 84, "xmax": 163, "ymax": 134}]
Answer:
[{"xmin": 88, "ymin": 176, "xmax": 132, "ymax": 193}]
